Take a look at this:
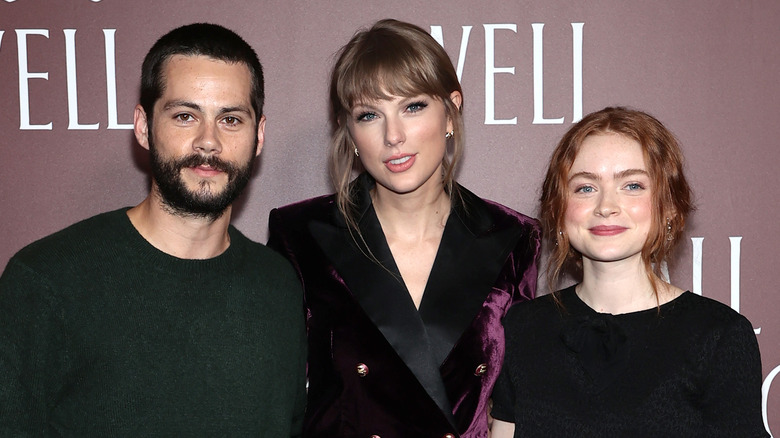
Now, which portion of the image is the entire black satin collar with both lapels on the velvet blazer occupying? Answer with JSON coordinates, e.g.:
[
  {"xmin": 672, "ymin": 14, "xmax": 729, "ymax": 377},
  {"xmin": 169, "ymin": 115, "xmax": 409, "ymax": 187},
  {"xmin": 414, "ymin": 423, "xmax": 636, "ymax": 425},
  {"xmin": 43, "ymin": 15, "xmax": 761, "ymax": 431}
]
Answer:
[{"xmin": 310, "ymin": 173, "xmax": 519, "ymax": 421}]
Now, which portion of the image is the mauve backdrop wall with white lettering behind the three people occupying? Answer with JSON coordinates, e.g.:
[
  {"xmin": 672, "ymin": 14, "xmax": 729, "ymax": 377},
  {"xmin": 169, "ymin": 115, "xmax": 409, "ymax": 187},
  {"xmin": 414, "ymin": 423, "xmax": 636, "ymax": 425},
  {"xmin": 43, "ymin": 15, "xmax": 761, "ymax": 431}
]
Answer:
[{"xmin": 0, "ymin": 0, "xmax": 780, "ymax": 436}]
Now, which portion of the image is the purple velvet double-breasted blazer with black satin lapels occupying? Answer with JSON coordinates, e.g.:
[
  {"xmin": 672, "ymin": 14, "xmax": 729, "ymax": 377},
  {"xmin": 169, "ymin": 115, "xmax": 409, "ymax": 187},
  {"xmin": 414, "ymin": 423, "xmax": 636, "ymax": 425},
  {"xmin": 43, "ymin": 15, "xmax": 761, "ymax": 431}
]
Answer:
[{"xmin": 268, "ymin": 174, "xmax": 540, "ymax": 438}]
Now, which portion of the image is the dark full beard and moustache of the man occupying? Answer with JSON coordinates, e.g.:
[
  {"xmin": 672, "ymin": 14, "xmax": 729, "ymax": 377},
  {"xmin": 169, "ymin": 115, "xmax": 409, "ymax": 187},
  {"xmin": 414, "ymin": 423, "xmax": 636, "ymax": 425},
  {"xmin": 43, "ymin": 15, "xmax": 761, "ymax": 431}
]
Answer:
[{"xmin": 149, "ymin": 136, "xmax": 257, "ymax": 221}]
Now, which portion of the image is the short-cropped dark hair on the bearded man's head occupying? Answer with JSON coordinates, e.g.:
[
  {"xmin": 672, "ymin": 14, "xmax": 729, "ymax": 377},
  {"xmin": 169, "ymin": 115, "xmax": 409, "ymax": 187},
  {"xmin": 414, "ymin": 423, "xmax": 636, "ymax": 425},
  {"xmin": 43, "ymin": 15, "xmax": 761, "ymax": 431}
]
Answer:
[{"xmin": 141, "ymin": 23, "xmax": 265, "ymax": 123}]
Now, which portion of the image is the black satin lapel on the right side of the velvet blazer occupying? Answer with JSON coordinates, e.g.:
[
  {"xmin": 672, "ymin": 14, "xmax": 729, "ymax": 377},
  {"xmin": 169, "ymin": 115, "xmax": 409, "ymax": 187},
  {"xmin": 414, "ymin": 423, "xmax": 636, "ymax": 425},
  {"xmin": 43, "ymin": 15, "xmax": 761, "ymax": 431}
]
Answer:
[{"xmin": 420, "ymin": 209, "xmax": 522, "ymax": 364}]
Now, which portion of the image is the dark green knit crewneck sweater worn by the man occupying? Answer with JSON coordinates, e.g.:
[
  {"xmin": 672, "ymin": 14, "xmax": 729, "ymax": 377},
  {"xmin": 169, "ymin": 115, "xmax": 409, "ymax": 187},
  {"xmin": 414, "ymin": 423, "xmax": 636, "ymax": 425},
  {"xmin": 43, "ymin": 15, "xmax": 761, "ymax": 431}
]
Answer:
[{"xmin": 0, "ymin": 209, "xmax": 306, "ymax": 438}]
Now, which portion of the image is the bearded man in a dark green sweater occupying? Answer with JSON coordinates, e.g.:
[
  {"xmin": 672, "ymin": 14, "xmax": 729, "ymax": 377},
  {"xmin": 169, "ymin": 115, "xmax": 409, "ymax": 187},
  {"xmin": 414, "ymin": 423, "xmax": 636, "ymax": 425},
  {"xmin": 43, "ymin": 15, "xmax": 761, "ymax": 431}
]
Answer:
[{"xmin": 0, "ymin": 24, "xmax": 306, "ymax": 437}]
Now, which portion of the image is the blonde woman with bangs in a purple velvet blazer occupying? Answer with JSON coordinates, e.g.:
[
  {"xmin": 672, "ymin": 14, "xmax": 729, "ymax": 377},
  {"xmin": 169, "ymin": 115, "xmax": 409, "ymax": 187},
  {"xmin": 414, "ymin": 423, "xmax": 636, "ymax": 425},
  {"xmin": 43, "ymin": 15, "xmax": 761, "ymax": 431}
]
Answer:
[{"xmin": 269, "ymin": 20, "xmax": 539, "ymax": 438}]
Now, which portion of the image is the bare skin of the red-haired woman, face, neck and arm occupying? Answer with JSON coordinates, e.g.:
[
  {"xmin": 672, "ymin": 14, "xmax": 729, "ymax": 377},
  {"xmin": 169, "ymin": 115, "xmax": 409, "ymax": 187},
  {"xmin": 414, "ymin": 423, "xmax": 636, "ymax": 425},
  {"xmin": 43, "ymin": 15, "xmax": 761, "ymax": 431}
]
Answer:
[{"xmin": 491, "ymin": 133, "xmax": 683, "ymax": 438}]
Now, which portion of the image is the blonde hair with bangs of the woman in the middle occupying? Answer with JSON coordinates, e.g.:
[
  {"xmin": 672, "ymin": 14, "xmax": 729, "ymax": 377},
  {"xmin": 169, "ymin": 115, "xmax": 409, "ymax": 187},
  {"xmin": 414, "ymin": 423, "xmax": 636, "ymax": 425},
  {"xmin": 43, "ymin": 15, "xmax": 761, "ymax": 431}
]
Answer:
[{"xmin": 328, "ymin": 19, "xmax": 464, "ymax": 229}]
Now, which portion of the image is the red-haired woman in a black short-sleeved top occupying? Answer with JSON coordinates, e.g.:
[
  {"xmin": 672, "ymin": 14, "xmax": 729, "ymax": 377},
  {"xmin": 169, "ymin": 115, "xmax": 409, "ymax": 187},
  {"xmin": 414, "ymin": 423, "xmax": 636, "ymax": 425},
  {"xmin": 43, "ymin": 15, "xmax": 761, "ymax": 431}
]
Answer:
[{"xmin": 493, "ymin": 108, "xmax": 767, "ymax": 438}]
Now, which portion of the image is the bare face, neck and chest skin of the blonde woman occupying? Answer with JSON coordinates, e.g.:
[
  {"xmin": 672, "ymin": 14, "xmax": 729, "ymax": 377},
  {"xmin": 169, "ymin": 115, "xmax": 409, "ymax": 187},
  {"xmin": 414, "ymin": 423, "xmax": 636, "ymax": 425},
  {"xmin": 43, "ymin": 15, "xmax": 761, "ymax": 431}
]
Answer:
[{"xmin": 347, "ymin": 91, "xmax": 462, "ymax": 308}]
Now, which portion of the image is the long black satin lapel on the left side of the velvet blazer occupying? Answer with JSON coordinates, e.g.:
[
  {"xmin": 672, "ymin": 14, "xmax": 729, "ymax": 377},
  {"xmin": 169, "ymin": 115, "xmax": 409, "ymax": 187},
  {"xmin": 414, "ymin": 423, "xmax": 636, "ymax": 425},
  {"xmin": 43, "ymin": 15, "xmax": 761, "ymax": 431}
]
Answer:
[{"xmin": 309, "ymin": 208, "xmax": 454, "ymax": 421}]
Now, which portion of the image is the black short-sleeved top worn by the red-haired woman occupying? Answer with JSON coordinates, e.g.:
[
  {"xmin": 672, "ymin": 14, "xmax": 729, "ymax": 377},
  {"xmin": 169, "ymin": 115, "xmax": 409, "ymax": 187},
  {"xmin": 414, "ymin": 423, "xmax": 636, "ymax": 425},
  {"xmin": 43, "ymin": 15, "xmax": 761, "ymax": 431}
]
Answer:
[{"xmin": 493, "ymin": 287, "xmax": 768, "ymax": 438}]
